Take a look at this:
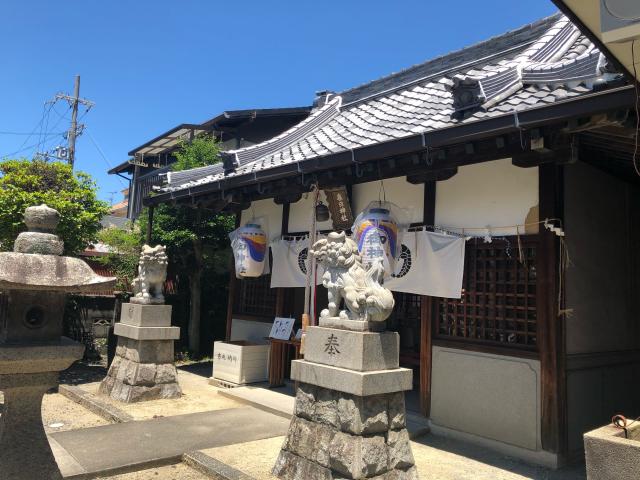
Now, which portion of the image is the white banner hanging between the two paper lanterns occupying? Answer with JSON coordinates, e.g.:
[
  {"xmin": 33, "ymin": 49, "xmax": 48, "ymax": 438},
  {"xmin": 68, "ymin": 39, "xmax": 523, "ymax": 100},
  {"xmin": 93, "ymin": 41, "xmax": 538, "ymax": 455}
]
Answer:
[{"xmin": 271, "ymin": 237, "xmax": 323, "ymax": 288}]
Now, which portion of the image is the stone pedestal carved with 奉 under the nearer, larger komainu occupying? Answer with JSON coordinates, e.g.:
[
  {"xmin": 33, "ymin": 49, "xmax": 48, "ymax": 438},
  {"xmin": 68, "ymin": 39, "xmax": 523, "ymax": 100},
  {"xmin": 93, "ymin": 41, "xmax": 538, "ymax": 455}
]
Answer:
[{"xmin": 273, "ymin": 327, "xmax": 418, "ymax": 480}]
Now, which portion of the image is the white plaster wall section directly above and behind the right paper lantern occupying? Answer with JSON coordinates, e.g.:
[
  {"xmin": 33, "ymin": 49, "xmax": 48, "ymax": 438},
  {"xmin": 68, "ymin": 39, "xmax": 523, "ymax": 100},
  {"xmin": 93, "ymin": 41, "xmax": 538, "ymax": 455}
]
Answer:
[{"xmin": 353, "ymin": 177, "xmax": 424, "ymax": 223}]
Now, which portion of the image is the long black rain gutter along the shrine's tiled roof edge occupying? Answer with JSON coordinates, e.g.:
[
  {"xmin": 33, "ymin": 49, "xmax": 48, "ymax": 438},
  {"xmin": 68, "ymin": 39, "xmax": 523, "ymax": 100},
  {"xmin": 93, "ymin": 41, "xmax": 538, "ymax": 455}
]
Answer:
[{"xmin": 143, "ymin": 85, "xmax": 635, "ymax": 206}]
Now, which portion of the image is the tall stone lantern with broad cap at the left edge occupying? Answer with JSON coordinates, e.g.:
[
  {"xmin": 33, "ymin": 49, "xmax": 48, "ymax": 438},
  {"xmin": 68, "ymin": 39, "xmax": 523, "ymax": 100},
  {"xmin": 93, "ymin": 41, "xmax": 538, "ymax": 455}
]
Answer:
[{"xmin": 0, "ymin": 205, "xmax": 115, "ymax": 480}]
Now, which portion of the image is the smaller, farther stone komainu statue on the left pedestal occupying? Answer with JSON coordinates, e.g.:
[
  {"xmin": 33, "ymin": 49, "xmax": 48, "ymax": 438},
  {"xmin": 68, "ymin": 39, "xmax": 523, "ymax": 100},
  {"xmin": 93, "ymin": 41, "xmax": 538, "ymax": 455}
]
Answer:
[{"xmin": 130, "ymin": 245, "xmax": 169, "ymax": 304}]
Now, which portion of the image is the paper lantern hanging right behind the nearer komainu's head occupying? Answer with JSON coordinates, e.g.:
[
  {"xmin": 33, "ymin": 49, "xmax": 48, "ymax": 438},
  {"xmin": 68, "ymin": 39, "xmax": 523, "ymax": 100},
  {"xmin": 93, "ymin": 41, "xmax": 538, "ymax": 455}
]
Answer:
[{"xmin": 354, "ymin": 208, "xmax": 398, "ymax": 273}]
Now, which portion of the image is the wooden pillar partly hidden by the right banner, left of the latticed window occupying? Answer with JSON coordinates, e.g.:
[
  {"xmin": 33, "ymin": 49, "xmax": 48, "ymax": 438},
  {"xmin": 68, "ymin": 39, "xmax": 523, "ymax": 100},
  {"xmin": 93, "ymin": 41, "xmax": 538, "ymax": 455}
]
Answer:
[{"xmin": 420, "ymin": 181, "xmax": 436, "ymax": 417}]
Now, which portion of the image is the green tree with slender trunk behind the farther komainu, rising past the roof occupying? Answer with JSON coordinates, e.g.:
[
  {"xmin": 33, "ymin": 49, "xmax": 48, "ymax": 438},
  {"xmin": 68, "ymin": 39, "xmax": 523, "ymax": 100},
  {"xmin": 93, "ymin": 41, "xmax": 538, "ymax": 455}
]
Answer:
[{"xmin": 140, "ymin": 135, "xmax": 234, "ymax": 352}]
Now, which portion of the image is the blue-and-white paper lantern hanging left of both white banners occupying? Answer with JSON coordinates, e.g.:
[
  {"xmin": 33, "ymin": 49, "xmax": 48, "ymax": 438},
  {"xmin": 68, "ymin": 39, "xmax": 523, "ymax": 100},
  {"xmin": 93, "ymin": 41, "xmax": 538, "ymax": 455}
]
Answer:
[{"xmin": 231, "ymin": 223, "xmax": 267, "ymax": 277}]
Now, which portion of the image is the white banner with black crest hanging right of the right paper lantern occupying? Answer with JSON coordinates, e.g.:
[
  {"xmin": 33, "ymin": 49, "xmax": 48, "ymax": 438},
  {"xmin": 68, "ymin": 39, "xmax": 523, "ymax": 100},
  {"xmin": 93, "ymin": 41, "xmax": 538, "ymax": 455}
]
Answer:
[{"xmin": 384, "ymin": 231, "xmax": 465, "ymax": 298}]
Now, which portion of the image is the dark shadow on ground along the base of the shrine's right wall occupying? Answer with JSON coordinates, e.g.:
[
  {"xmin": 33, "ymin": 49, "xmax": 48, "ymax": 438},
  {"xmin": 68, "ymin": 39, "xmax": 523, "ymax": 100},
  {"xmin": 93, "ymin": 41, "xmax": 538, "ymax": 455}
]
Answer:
[{"xmin": 414, "ymin": 435, "xmax": 587, "ymax": 480}]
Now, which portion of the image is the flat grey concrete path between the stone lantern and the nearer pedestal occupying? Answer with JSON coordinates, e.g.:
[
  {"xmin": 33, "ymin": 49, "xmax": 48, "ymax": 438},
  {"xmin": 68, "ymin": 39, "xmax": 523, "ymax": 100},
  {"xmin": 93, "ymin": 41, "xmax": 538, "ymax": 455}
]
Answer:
[{"xmin": 50, "ymin": 407, "xmax": 289, "ymax": 478}]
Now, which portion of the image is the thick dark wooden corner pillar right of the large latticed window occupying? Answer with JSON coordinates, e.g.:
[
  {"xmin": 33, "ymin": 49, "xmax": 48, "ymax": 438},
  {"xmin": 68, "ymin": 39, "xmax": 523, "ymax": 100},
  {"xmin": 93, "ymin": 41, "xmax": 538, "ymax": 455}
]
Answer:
[{"xmin": 537, "ymin": 163, "xmax": 567, "ymax": 454}]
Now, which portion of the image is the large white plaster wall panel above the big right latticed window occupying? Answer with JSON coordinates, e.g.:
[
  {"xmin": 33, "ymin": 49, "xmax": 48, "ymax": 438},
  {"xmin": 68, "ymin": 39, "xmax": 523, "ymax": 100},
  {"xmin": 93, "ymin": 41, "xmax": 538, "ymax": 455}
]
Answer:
[{"xmin": 435, "ymin": 158, "xmax": 538, "ymax": 235}]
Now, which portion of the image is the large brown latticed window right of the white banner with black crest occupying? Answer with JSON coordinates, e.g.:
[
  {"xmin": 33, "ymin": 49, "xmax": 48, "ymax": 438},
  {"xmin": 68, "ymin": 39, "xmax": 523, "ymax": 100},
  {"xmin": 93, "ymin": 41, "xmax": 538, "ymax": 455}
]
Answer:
[{"xmin": 435, "ymin": 235, "xmax": 537, "ymax": 350}]
